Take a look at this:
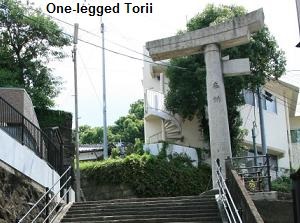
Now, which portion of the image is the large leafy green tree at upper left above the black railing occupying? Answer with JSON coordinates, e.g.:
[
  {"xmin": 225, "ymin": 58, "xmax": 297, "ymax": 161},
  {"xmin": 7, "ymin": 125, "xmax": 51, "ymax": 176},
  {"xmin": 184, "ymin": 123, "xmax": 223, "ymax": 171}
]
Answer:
[{"xmin": 0, "ymin": 0, "xmax": 70, "ymax": 108}]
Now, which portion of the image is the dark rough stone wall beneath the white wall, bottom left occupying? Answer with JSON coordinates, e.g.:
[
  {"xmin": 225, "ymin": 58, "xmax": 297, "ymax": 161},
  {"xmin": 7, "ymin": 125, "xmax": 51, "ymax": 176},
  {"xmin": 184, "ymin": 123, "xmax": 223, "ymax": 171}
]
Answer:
[{"xmin": 0, "ymin": 163, "xmax": 44, "ymax": 223}]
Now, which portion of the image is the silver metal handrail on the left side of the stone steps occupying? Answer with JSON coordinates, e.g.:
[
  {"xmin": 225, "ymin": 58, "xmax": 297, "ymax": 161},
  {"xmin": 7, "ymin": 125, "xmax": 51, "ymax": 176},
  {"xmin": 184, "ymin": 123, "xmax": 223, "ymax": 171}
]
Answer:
[{"xmin": 17, "ymin": 166, "xmax": 71, "ymax": 223}]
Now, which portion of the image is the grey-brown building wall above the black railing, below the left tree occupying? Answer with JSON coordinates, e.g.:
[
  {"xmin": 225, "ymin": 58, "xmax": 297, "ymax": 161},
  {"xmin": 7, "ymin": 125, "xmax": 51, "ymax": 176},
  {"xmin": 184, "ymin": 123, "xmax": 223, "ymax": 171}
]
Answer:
[{"xmin": 0, "ymin": 88, "xmax": 39, "ymax": 127}]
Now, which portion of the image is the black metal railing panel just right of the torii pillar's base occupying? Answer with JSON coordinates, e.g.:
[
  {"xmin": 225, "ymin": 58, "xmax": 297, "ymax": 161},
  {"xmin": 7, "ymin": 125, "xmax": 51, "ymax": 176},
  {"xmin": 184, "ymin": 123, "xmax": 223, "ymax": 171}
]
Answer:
[{"xmin": 231, "ymin": 155, "xmax": 271, "ymax": 192}]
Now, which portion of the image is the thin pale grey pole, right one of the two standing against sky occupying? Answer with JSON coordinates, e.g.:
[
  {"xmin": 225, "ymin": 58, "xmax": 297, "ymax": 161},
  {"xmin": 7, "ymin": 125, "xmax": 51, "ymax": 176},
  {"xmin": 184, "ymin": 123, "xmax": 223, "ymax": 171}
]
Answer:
[{"xmin": 101, "ymin": 17, "xmax": 108, "ymax": 159}]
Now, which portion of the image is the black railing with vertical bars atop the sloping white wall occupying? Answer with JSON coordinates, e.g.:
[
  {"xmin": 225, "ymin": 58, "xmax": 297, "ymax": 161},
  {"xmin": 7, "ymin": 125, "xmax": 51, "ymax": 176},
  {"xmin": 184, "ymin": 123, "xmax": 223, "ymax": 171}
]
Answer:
[{"xmin": 0, "ymin": 97, "xmax": 63, "ymax": 174}]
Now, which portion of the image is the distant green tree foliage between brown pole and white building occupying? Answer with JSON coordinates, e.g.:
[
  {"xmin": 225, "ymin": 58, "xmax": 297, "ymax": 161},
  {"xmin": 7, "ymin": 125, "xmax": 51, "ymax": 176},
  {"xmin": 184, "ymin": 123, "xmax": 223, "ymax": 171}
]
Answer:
[{"xmin": 79, "ymin": 100, "xmax": 144, "ymax": 144}]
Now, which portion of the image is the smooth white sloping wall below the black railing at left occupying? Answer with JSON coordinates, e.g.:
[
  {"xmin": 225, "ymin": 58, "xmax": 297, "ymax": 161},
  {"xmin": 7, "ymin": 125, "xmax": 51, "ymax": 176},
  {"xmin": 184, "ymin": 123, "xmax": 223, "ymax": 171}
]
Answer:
[{"xmin": 0, "ymin": 130, "xmax": 59, "ymax": 191}]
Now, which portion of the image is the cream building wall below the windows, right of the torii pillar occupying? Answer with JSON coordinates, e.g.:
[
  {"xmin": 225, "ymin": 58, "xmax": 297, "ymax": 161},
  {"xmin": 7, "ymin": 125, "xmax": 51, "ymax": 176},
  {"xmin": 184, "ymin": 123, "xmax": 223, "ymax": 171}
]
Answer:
[{"xmin": 240, "ymin": 89, "xmax": 289, "ymax": 168}]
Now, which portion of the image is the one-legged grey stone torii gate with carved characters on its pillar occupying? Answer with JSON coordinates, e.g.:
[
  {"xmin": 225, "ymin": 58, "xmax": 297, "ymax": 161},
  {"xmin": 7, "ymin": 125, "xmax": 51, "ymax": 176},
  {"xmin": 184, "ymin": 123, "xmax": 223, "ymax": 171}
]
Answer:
[{"xmin": 146, "ymin": 9, "xmax": 264, "ymax": 188}]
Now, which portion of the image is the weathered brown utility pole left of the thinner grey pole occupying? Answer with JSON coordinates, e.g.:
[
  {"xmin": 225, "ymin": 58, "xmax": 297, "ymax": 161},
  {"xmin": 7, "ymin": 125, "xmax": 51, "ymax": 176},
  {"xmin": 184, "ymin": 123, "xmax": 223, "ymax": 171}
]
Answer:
[{"xmin": 73, "ymin": 23, "xmax": 80, "ymax": 201}]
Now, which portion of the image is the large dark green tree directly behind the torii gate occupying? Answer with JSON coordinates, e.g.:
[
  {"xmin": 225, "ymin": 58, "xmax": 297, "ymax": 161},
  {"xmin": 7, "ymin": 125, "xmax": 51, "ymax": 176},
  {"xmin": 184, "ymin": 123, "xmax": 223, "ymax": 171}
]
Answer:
[{"xmin": 166, "ymin": 5, "xmax": 286, "ymax": 155}]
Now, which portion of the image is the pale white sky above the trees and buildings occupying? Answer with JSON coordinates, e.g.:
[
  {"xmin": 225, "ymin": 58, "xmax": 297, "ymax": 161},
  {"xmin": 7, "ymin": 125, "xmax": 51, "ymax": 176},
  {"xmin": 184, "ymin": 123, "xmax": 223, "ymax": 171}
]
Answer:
[{"xmin": 30, "ymin": 0, "xmax": 300, "ymax": 126}]
